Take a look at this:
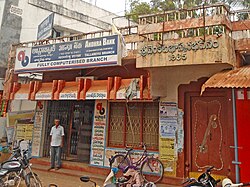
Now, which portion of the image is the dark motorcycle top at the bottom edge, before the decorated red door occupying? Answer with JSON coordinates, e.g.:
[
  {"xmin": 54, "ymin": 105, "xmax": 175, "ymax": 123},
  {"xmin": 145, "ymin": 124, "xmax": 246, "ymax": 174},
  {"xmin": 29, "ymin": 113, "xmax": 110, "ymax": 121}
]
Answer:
[{"xmin": 182, "ymin": 166, "xmax": 220, "ymax": 187}]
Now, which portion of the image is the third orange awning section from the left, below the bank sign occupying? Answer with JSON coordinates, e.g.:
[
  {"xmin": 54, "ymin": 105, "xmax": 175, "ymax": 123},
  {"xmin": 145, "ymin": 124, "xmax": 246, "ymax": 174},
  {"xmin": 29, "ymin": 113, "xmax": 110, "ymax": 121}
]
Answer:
[{"xmin": 55, "ymin": 79, "xmax": 83, "ymax": 100}]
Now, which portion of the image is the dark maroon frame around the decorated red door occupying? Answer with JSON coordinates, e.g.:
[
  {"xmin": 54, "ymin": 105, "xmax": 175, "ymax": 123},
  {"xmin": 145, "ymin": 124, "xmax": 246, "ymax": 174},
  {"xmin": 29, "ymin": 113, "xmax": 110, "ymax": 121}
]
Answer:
[{"xmin": 178, "ymin": 78, "xmax": 235, "ymax": 177}]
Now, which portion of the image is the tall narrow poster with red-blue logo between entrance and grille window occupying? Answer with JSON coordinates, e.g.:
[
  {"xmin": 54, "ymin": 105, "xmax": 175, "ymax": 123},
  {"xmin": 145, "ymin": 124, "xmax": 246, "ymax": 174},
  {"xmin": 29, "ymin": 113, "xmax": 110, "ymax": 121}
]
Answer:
[{"xmin": 90, "ymin": 100, "xmax": 107, "ymax": 166}]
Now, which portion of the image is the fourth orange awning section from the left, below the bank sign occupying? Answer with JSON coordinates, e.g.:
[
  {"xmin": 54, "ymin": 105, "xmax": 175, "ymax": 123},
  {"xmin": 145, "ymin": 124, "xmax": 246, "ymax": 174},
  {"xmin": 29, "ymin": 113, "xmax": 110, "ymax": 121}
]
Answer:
[{"xmin": 80, "ymin": 77, "xmax": 113, "ymax": 100}]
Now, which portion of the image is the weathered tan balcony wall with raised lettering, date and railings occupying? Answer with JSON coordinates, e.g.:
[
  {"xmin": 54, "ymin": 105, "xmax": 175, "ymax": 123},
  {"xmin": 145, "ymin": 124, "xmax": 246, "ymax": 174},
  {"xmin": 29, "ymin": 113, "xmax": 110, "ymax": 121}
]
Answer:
[{"xmin": 136, "ymin": 4, "xmax": 250, "ymax": 68}]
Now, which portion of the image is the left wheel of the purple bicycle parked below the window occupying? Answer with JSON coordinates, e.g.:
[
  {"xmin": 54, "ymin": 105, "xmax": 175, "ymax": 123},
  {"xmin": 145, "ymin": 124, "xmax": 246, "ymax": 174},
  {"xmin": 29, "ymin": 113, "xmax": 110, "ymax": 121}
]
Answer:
[{"xmin": 109, "ymin": 154, "xmax": 129, "ymax": 173}]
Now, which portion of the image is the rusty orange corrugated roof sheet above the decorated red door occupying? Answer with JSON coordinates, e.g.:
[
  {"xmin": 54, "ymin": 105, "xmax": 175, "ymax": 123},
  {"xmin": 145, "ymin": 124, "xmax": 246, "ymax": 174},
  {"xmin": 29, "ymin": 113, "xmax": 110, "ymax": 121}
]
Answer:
[{"xmin": 201, "ymin": 66, "xmax": 250, "ymax": 94}]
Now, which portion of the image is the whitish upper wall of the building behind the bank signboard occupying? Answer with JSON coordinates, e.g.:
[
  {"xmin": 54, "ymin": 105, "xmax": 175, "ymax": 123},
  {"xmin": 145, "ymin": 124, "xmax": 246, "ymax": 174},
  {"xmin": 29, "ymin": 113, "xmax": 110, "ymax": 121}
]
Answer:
[{"xmin": 0, "ymin": 0, "xmax": 128, "ymax": 69}]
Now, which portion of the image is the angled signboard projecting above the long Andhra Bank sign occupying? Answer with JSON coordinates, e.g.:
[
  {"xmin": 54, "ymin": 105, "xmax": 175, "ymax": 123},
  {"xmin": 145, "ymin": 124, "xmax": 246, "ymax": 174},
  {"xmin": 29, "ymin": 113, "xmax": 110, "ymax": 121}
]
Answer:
[{"xmin": 37, "ymin": 13, "xmax": 54, "ymax": 40}]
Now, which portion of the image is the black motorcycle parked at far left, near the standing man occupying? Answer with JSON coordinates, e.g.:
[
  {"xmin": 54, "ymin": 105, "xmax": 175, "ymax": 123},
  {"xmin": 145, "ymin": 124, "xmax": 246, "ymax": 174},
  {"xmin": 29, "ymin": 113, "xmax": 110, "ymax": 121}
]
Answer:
[{"xmin": 0, "ymin": 140, "xmax": 42, "ymax": 187}]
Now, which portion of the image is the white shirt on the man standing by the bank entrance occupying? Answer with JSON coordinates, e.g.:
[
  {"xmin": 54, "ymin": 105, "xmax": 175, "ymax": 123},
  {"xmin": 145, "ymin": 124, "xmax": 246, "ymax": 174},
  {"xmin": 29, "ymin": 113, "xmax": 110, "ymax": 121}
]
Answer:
[{"xmin": 50, "ymin": 125, "xmax": 64, "ymax": 146}]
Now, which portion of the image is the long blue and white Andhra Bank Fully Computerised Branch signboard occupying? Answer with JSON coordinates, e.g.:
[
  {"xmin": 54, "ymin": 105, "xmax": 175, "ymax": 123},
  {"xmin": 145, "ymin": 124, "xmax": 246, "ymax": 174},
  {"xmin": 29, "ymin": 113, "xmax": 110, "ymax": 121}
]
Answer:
[{"xmin": 15, "ymin": 35, "xmax": 121, "ymax": 73}]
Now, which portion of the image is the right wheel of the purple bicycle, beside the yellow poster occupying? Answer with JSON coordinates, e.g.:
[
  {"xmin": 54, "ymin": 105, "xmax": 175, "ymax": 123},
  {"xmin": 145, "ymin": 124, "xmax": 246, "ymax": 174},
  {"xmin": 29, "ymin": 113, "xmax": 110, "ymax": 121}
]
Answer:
[{"xmin": 140, "ymin": 158, "xmax": 164, "ymax": 183}]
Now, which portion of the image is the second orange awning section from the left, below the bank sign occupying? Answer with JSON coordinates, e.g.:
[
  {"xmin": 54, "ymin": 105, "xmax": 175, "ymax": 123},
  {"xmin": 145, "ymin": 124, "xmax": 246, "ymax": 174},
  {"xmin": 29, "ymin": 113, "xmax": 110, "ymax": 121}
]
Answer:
[{"xmin": 31, "ymin": 80, "xmax": 58, "ymax": 100}]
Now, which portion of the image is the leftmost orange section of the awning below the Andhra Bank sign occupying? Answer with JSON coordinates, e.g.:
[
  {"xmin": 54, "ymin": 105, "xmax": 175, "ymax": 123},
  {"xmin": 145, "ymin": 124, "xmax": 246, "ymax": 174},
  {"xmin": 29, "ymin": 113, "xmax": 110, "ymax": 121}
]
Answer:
[{"xmin": 10, "ymin": 81, "xmax": 34, "ymax": 100}]
